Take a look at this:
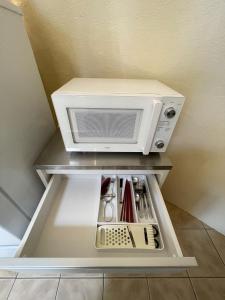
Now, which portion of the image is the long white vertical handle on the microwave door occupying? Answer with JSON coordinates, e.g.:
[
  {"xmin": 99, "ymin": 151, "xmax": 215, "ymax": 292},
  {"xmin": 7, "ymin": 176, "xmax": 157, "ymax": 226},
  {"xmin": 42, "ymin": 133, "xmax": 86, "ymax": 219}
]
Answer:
[{"xmin": 143, "ymin": 100, "xmax": 163, "ymax": 155}]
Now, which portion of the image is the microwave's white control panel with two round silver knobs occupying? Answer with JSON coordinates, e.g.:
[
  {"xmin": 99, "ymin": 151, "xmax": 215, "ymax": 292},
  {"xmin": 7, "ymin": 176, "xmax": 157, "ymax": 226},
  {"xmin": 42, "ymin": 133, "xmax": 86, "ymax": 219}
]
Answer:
[{"xmin": 151, "ymin": 98, "xmax": 183, "ymax": 152}]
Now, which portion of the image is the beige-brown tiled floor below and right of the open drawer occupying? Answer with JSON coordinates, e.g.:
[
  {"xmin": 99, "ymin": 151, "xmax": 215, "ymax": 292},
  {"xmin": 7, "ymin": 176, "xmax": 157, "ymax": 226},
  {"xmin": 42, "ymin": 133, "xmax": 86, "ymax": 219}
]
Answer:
[{"xmin": 0, "ymin": 203, "xmax": 225, "ymax": 300}]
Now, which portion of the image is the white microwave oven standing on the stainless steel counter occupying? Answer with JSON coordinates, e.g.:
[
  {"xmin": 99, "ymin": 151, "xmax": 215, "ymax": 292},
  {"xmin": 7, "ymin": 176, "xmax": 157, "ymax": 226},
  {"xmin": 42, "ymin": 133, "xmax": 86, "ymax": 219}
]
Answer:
[{"xmin": 52, "ymin": 78, "xmax": 184, "ymax": 155}]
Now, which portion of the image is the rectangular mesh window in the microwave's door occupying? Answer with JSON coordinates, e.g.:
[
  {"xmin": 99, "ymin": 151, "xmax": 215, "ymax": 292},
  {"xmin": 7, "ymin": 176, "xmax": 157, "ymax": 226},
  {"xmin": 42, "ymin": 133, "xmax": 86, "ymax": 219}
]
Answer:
[{"xmin": 69, "ymin": 108, "xmax": 142, "ymax": 143}]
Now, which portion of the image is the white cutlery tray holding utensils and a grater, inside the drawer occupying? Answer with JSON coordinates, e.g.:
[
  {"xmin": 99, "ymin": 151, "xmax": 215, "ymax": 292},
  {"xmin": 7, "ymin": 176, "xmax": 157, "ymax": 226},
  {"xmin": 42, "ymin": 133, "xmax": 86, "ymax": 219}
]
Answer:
[{"xmin": 95, "ymin": 175, "xmax": 164, "ymax": 251}]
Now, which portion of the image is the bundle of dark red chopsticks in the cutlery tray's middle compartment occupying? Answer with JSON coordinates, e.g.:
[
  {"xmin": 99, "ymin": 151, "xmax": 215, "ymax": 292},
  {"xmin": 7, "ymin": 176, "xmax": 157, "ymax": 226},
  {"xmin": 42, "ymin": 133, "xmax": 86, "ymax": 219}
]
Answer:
[{"xmin": 120, "ymin": 180, "xmax": 134, "ymax": 223}]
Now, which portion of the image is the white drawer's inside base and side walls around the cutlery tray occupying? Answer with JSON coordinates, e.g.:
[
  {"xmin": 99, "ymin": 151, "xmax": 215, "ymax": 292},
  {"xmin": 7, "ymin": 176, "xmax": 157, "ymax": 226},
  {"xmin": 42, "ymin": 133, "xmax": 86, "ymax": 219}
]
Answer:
[{"xmin": 17, "ymin": 174, "xmax": 183, "ymax": 259}]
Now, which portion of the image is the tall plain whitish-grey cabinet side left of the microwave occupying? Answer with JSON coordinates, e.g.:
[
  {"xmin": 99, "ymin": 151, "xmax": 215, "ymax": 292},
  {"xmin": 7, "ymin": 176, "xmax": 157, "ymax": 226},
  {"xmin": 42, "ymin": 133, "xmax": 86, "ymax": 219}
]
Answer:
[{"xmin": 0, "ymin": 0, "xmax": 55, "ymax": 248}]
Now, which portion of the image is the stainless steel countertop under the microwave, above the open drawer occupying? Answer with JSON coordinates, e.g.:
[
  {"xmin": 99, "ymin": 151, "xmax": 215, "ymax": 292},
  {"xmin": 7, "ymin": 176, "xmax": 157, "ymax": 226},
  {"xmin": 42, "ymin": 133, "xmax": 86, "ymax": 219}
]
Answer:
[{"xmin": 34, "ymin": 130, "xmax": 172, "ymax": 171}]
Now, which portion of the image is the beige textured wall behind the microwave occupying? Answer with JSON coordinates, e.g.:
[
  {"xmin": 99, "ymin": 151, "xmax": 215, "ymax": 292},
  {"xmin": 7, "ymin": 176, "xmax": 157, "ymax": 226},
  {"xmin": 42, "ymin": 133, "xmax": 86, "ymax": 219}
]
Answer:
[{"xmin": 21, "ymin": 0, "xmax": 225, "ymax": 233}]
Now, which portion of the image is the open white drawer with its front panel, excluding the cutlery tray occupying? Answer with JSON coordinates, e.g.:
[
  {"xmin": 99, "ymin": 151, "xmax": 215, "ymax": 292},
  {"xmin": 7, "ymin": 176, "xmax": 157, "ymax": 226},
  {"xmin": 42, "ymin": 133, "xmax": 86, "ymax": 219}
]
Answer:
[{"xmin": 0, "ymin": 174, "xmax": 197, "ymax": 272}]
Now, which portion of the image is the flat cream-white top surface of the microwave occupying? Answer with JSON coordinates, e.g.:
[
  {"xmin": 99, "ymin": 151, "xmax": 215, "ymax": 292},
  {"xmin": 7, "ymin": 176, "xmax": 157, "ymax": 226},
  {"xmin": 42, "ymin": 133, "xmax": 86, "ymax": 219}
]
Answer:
[{"xmin": 52, "ymin": 78, "xmax": 183, "ymax": 97}]
